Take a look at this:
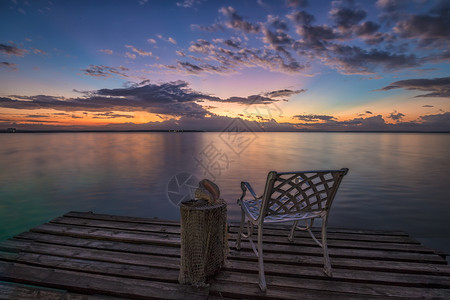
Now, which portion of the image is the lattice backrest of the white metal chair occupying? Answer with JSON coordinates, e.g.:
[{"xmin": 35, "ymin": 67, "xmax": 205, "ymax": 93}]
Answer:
[{"xmin": 261, "ymin": 168, "xmax": 348, "ymax": 216}]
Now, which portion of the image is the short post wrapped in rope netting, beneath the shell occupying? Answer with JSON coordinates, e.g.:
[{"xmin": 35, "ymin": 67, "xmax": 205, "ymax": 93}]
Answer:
[{"xmin": 178, "ymin": 200, "xmax": 229, "ymax": 286}]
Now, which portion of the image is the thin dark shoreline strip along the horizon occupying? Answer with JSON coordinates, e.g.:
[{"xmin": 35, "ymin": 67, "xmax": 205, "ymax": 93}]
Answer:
[{"xmin": 0, "ymin": 129, "xmax": 450, "ymax": 134}]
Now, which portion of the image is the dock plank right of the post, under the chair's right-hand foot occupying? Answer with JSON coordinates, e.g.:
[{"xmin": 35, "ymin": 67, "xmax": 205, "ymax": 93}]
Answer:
[{"xmin": 225, "ymin": 260, "xmax": 450, "ymax": 289}]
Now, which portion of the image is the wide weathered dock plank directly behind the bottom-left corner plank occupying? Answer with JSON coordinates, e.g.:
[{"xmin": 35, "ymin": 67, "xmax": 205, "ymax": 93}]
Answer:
[{"xmin": 0, "ymin": 261, "xmax": 208, "ymax": 299}]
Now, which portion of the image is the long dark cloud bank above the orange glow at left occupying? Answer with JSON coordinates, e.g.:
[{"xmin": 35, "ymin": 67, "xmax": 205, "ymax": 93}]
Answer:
[{"xmin": 0, "ymin": 81, "xmax": 216, "ymax": 118}]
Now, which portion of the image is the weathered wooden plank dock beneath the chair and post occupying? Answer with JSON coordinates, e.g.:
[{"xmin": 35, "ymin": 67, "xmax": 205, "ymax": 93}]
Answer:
[{"xmin": 0, "ymin": 212, "xmax": 450, "ymax": 299}]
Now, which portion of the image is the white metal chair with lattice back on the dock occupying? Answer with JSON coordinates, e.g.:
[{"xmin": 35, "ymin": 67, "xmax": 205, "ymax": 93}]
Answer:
[{"xmin": 236, "ymin": 168, "xmax": 348, "ymax": 291}]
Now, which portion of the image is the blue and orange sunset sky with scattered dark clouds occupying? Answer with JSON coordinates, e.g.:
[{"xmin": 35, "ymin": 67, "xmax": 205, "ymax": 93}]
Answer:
[{"xmin": 0, "ymin": 0, "xmax": 450, "ymax": 131}]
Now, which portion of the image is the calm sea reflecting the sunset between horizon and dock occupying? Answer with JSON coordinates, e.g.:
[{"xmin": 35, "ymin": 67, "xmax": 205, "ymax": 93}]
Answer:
[{"xmin": 0, "ymin": 132, "xmax": 450, "ymax": 253}]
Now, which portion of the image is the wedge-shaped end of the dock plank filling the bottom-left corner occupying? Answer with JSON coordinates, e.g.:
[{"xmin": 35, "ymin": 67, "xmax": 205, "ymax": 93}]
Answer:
[{"xmin": 0, "ymin": 281, "xmax": 119, "ymax": 300}]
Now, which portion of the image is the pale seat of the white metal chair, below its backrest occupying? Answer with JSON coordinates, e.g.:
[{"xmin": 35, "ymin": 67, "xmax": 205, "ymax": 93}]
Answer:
[{"xmin": 242, "ymin": 199, "xmax": 324, "ymax": 223}]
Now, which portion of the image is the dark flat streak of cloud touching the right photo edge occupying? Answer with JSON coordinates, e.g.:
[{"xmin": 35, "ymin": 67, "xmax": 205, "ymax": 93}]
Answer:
[{"xmin": 380, "ymin": 77, "xmax": 450, "ymax": 98}]
